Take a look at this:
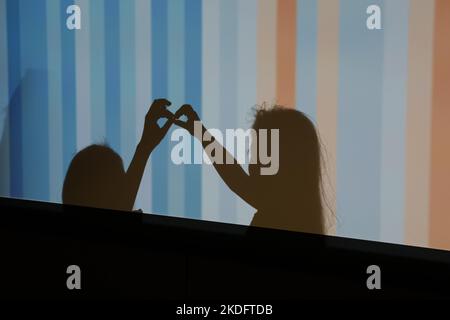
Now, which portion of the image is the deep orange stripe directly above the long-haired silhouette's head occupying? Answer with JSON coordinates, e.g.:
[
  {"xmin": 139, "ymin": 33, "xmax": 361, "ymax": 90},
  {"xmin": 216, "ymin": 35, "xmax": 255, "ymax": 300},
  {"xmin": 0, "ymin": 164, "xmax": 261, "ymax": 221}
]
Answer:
[{"xmin": 277, "ymin": 0, "xmax": 297, "ymax": 108}]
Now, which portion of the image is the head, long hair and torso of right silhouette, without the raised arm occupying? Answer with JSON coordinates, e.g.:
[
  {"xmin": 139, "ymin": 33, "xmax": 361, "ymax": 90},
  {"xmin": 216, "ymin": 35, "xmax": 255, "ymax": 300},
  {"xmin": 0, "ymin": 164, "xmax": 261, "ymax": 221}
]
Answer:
[{"xmin": 249, "ymin": 106, "xmax": 327, "ymax": 234}]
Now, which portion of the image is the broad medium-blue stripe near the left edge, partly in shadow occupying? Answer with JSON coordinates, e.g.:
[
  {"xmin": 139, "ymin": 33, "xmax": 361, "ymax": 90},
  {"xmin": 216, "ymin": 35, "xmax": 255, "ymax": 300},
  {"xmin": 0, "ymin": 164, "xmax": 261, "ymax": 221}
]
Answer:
[{"xmin": 20, "ymin": 0, "xmax": 49, "ymax": 201}]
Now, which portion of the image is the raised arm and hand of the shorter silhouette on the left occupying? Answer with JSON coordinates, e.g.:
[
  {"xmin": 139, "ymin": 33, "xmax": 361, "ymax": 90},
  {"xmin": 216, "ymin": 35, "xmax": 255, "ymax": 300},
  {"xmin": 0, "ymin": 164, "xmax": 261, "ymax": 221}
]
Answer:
[{"xmin": 125, "ymin": 99, "xmax": 174, "ymax": 208}]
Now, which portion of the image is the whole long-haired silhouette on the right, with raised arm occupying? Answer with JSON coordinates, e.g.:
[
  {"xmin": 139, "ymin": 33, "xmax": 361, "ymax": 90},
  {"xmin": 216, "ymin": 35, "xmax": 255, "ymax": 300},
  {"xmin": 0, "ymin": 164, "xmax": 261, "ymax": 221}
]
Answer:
[{"xmin": 174, "ymin": 105, "xmax": 324, "ymax": 234}]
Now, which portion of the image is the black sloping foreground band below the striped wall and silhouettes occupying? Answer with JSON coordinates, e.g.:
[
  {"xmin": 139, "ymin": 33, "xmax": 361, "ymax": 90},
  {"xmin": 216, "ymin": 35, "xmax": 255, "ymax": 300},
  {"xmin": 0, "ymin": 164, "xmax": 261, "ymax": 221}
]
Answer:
[{"xmin": 0, "ymin": 198, "xmax": 450, "ymax": 301}]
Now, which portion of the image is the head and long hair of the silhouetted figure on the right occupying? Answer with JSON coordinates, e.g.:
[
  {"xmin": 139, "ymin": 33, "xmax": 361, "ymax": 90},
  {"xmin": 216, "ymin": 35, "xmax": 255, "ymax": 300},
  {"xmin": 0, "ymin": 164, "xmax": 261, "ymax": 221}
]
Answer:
[{"xmin": 249, "ymin": 106, "xmax": 322, "ymax": 234}]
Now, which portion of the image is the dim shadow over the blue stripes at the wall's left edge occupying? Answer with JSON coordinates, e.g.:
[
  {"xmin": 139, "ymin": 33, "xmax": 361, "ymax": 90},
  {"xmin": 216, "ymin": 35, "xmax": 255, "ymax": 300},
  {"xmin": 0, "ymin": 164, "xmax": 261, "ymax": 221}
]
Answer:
[{"xmin": 0, "ymin": 69, "xmax": 49, "ymax": 200}]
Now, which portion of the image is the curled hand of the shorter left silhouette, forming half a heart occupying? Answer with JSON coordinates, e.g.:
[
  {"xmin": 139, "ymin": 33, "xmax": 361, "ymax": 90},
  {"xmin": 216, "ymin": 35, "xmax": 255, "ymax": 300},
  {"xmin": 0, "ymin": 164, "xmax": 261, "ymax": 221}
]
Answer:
[{"xmin": 141, "ymin": 99, "xmax": 175, "ymax": 150}]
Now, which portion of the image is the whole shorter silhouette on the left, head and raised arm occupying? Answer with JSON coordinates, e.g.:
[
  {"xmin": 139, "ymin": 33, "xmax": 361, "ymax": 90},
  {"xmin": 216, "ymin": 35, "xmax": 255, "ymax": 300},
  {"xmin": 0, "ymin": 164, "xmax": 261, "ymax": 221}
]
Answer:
[{"xmin": 62, "ymin": 99, "xmax": 174, "ymax": 211}]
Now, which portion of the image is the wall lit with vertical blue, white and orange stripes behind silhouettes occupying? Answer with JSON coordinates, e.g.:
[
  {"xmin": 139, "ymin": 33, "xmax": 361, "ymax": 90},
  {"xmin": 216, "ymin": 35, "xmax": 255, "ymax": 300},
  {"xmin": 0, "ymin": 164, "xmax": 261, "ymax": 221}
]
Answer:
[{"xmin": 0, "ymin": 0, "xmax": 450, "ymax": 249}]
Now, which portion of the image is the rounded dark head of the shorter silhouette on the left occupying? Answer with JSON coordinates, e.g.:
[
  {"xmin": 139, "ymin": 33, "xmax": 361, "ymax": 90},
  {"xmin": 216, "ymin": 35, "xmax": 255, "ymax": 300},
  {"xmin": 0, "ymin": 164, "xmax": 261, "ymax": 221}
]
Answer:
[{"xmin": 62, "ymin": 145, "xmax": 132, "ymax": 210}]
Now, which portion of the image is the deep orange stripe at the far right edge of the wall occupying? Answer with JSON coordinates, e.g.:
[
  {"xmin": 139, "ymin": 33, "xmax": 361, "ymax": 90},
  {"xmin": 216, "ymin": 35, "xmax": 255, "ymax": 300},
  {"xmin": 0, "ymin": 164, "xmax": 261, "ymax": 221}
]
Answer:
[{"xmin": 430, "ymin": 0, "xmax": 450, "ymax": 249}]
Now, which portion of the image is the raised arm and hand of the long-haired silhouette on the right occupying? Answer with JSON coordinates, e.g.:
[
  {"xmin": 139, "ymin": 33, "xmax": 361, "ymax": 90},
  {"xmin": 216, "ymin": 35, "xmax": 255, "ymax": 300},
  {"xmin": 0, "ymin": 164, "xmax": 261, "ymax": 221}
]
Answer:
[{"xmin": 174, "ymin": 105, "xmax": 258, "ymax": 208}]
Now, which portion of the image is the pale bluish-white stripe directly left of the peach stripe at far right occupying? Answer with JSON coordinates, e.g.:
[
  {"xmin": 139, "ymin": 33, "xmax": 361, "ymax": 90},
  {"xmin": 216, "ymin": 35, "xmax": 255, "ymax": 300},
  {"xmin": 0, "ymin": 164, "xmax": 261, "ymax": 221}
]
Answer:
[{"xmin": 380, "ymin": 0, "xmax": 409, "ymax": 243}]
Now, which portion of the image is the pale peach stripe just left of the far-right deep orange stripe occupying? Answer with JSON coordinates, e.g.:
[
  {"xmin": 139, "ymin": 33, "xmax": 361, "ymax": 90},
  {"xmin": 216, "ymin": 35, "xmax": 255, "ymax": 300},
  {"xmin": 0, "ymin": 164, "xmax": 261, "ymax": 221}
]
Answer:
[{"xmin": 405, "ymin": 0, "xmax": 434, "ymax": 246}]
